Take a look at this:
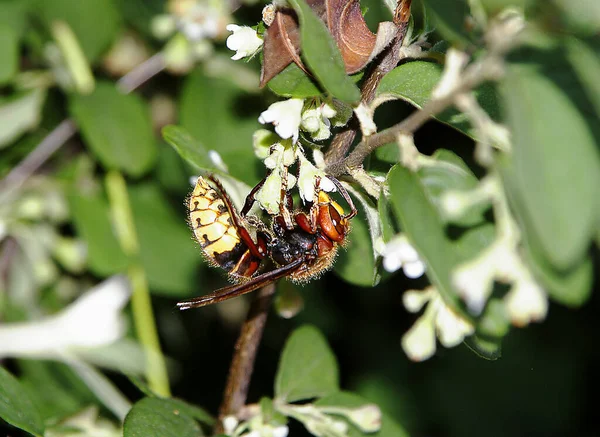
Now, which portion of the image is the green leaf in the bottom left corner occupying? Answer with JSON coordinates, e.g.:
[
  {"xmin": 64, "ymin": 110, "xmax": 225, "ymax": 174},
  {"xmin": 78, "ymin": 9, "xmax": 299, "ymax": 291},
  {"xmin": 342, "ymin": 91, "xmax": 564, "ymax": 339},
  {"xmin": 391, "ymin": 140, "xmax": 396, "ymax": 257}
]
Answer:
[{"xmin": 0, "ymin": 367, "xmax": 44, "ymax": 436}]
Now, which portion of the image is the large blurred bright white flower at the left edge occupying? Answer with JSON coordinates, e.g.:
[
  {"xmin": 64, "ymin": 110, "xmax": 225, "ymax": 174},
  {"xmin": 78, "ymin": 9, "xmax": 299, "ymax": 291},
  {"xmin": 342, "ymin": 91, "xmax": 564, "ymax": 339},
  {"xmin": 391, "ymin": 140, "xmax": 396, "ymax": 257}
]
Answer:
[{"xmin": 0, "ymin": 276, "xmax": 130, "ymax": 359}]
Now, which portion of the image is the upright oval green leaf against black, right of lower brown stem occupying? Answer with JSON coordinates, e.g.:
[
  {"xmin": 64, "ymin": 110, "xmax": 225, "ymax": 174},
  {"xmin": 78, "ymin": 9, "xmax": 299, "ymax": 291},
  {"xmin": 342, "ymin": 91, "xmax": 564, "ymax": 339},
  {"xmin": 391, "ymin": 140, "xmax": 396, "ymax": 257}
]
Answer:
[{"xmin": 275, "ymin": 325, "xmax": 339, "ymax": 402}]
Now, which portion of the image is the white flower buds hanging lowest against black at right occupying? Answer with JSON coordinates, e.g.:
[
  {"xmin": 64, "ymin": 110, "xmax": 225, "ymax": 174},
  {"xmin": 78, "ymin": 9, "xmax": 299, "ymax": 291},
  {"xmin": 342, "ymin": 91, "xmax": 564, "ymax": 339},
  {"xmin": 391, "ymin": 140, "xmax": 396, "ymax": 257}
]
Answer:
[{"xmin": 402, "ymin": 287, "xmax": 475, "ymax": 361}]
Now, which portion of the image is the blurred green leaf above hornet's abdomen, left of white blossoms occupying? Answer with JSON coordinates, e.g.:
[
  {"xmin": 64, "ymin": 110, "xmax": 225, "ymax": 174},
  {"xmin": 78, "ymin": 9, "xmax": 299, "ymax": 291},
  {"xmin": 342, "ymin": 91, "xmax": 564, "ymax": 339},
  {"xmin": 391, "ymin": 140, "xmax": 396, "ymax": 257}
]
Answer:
[{"xmin": 180, "ymin": 72, "xmax": 266, "ymax": 186}]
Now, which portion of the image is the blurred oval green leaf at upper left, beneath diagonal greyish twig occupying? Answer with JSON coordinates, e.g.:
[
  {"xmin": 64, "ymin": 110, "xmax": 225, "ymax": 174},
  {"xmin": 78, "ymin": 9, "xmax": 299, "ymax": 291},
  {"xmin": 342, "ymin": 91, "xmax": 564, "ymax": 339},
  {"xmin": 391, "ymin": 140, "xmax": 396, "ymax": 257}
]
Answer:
[{"xmin": 70, "ymin": 82, "xmax": 157, "ymax": 177}]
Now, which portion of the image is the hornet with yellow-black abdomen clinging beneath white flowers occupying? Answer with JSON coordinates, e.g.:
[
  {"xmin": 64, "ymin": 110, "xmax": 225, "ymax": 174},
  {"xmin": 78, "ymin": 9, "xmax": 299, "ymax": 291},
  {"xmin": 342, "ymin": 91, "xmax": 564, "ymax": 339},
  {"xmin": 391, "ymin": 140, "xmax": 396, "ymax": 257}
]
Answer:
[{"xmin": 177, "ymin": 175, "xmax": 357, "ymax": 310}]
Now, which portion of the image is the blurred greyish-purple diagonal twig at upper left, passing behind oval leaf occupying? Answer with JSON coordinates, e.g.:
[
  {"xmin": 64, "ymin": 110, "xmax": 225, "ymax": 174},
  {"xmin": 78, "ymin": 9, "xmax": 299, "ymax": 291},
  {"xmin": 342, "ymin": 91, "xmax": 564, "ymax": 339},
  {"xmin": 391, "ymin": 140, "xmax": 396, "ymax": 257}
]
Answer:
[{"xmin": 0, "ymin": 53, "xmax": 166, "ymax": 199}]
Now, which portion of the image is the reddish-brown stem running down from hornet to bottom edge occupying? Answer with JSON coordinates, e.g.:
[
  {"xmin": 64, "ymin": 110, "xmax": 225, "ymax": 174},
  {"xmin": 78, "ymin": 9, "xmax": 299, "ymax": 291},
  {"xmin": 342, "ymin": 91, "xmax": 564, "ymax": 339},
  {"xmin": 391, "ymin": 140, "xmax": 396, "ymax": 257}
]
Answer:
[{"xmin": 215, "ymin": 284, "xmax": 275, "ymax": 434}]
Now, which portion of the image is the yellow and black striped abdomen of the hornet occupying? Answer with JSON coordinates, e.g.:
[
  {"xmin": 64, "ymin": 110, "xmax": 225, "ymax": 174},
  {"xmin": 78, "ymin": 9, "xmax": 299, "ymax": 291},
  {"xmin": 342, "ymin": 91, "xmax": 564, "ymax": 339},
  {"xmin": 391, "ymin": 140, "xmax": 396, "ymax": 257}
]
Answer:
[{"xmin": 188, "ymin": 176, "xmax": 248, "ymax": 274}]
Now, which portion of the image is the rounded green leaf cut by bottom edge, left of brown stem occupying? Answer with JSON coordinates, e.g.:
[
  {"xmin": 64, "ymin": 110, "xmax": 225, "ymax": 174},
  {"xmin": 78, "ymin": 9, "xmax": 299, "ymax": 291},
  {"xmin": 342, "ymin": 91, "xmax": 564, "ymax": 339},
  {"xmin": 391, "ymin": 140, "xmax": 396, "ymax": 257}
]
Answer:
[{"xmin": 123, "ymin": 398, "xmax": 204, "ymax": 437}]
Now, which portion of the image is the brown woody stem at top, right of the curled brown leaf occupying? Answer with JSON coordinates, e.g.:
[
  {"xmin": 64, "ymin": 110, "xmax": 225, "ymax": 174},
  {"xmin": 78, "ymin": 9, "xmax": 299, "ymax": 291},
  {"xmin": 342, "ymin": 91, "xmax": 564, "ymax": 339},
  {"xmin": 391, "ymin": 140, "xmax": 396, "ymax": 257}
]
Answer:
[{"xmin": 325, "ymin": 0, "xmax": 412, "ymax": 165}]
